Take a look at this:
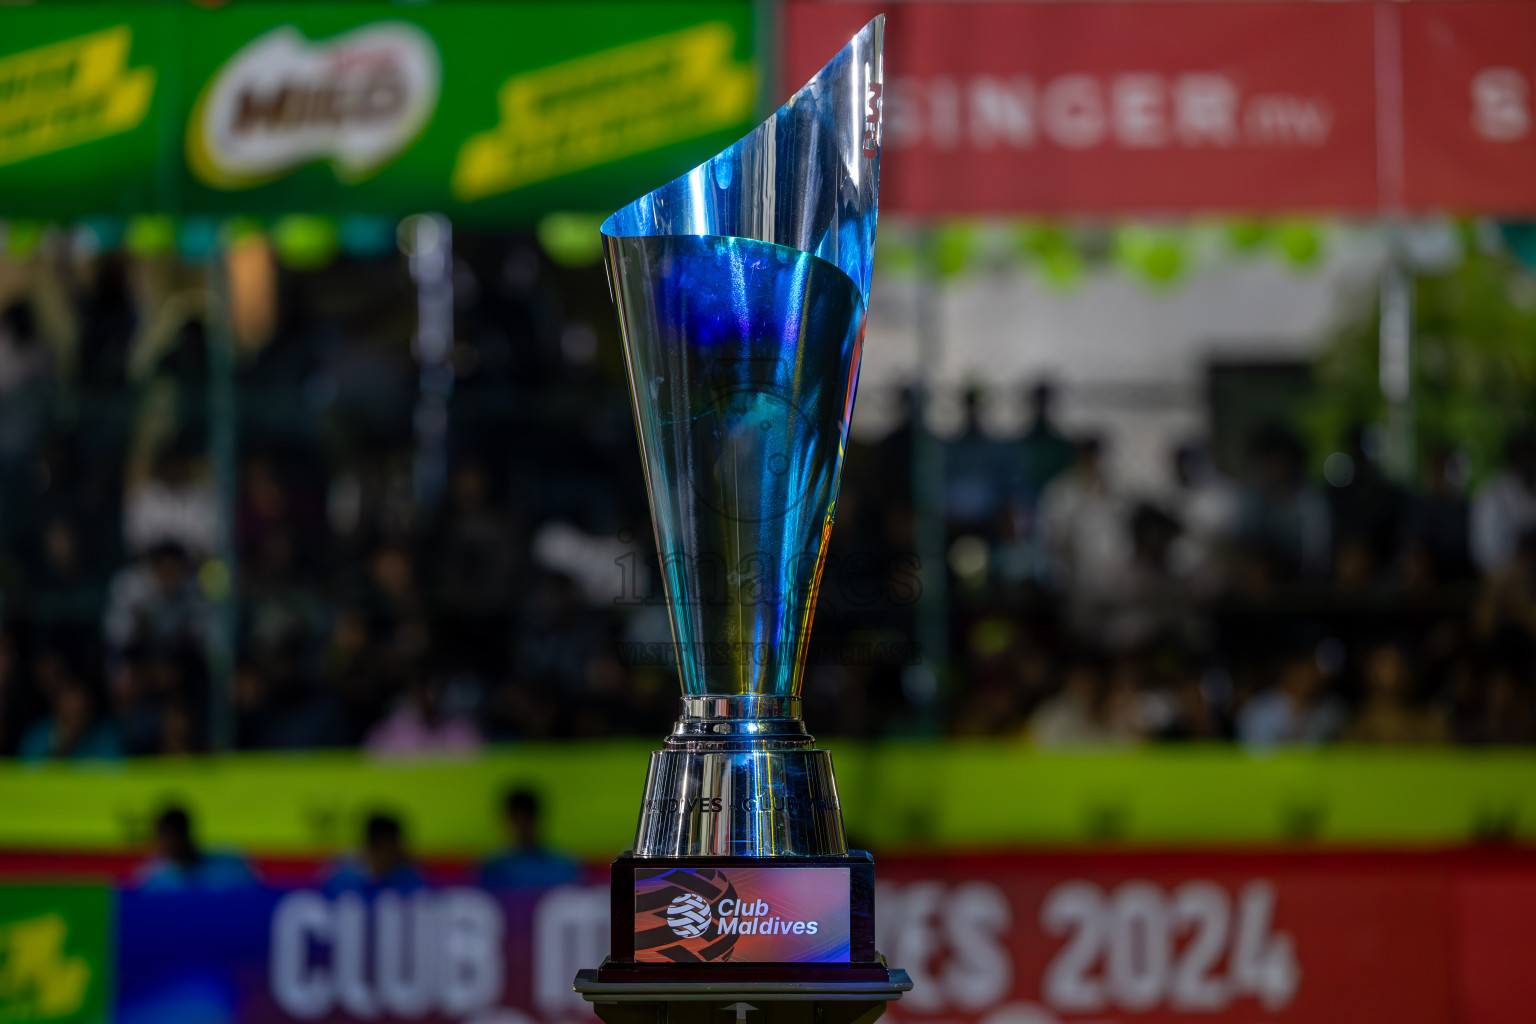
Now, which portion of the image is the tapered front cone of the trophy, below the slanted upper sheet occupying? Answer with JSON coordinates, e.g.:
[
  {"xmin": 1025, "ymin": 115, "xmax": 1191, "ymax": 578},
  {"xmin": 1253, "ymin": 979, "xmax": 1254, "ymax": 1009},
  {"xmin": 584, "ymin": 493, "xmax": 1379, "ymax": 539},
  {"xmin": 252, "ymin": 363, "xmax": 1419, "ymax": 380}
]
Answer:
[{"xmin": 608, "ymin": 235, "xmax": 863, "ymax": 694}]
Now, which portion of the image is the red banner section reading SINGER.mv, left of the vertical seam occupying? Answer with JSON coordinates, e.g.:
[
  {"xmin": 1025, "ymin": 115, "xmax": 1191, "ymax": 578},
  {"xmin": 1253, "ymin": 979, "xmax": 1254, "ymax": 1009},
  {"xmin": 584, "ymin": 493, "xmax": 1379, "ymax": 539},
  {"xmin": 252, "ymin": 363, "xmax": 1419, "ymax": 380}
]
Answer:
[{"xmin": 785, "ymin": 2, "xmax": 1376, "ymax": 215}]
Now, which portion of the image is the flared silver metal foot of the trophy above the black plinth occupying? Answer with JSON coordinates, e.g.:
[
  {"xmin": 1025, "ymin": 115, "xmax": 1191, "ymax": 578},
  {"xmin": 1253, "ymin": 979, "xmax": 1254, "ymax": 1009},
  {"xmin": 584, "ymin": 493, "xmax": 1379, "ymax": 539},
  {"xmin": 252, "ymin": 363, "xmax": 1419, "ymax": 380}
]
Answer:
[{"xmin": 634, "ymin": 694, "xmax": 848, "ymax": 857}]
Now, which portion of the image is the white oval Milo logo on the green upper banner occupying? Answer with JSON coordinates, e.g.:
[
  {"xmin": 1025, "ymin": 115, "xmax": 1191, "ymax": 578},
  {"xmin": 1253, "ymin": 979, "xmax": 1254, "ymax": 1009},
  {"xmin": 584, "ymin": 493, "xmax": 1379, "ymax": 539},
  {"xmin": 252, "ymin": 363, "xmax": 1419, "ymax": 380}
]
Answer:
[{"xmin": 186, "ymin": 21, "xmax": 442, "ymax": 189}]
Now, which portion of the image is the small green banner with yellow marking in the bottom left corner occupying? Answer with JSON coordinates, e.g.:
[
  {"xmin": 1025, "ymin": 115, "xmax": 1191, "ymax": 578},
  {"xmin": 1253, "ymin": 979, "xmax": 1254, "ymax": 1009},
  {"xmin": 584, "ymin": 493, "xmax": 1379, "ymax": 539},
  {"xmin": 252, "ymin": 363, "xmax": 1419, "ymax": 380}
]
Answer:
[{"xmin": 0, "ymin": 886, "xmax": 112, "ymax": 1024}]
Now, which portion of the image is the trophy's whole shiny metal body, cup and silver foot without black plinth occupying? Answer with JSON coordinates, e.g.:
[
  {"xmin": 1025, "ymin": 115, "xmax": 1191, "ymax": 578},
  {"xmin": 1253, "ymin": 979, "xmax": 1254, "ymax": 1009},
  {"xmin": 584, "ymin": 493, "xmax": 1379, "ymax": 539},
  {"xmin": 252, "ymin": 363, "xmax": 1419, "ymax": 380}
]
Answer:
[{"xmin": 602, "ymin": 17, "xmax": 885, "ymax": 857}]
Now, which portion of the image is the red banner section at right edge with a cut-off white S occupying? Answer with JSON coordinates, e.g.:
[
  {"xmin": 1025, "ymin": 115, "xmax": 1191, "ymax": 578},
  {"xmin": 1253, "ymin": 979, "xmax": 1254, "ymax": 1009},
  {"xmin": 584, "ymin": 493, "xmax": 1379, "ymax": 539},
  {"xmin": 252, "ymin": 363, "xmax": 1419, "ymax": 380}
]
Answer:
[{"xmin": 1393, "ymin": 0, "xmax": 1536, "ymax": 213}]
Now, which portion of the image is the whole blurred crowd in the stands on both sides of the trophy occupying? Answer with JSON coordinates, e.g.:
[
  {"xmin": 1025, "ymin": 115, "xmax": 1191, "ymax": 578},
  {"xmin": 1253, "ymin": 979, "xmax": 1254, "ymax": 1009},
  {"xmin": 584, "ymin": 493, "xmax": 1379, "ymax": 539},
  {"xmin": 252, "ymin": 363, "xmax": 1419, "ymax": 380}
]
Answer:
[{"xmin": 0, "ymin": 238, "xmax": 1536, "ymax": 758}]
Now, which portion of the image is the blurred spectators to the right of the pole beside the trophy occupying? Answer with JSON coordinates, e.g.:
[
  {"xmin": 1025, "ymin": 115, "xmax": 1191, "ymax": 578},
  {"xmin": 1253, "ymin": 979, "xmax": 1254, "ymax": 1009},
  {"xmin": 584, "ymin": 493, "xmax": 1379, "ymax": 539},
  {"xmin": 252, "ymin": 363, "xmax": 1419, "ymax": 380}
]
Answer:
[{"xmin": 927, "ymin": 388, "xmax": 1536, "ymax": 746}]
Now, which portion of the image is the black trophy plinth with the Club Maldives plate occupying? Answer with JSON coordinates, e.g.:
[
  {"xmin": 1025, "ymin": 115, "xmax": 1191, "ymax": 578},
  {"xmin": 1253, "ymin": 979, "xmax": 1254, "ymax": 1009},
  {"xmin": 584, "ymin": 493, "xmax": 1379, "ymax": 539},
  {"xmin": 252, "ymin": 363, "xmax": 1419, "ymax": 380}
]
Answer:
[{"xmin": 596, "ymin": 851, "xmax": 889, "ymax": 983}]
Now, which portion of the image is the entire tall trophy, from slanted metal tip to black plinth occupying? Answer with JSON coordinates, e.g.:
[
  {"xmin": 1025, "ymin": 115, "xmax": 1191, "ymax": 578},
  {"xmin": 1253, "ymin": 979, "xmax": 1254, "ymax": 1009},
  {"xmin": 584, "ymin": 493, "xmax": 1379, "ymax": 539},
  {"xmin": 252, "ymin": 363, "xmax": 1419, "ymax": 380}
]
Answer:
[{"xmin": 578, "ymin": 17, "xmax": 909, "ymax": 1000}]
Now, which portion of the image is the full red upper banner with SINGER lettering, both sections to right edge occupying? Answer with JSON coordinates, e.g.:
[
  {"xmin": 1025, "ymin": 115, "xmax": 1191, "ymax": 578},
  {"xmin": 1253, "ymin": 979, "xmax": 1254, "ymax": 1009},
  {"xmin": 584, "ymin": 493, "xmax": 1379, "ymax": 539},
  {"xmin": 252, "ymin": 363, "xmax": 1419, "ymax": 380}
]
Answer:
[{"xmin": 783, "ymin": 0, "xmax": 1536, "ymax": 216}]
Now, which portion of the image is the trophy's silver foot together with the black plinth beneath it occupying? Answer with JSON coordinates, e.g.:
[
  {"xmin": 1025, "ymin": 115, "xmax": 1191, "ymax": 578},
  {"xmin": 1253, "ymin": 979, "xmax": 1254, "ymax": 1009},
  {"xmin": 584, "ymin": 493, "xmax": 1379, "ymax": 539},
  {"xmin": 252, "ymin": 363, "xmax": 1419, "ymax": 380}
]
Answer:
[{"xmin": 589, "ymin": 706, "xmax": 911, "ymax": 1000}]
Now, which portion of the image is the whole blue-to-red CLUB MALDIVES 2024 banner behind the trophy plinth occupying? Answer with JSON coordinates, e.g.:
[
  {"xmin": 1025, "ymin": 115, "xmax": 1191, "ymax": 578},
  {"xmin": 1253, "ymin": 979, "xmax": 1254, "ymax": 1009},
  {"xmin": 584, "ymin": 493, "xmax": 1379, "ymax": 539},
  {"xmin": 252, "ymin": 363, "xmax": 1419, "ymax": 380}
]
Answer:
[{"xmin": 0, "ymin": 849, "xmax": 1536, "ymax": 1024}]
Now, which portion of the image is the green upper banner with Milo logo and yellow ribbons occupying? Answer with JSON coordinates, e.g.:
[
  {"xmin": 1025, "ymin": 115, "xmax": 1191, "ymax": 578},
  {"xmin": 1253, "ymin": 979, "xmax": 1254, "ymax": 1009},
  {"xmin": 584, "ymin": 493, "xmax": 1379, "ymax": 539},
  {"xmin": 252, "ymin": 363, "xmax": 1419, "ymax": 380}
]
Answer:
[{"xmin": 0, "ymin": 0, "xmax": 757, "ymax": 224}]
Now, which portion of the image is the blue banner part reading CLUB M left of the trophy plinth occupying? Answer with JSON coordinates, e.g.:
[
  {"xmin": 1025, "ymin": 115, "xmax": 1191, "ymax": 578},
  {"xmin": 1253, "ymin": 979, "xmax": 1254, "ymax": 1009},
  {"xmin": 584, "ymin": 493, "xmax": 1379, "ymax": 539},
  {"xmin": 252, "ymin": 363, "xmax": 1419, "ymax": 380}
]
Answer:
[{"xmin": 114, "ymin": 886, "xmax": 608, "ymax": 1024}]
